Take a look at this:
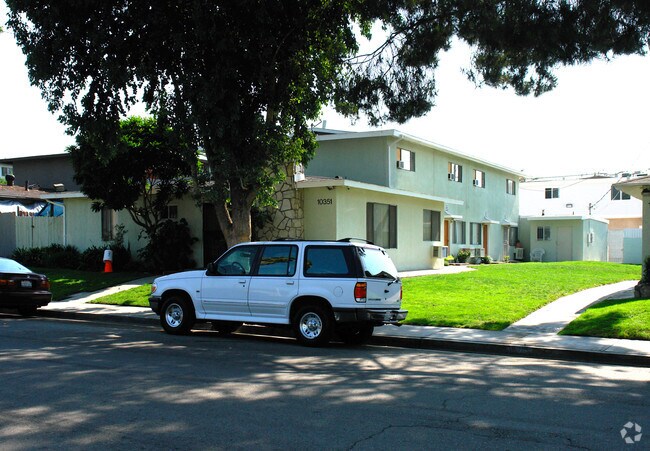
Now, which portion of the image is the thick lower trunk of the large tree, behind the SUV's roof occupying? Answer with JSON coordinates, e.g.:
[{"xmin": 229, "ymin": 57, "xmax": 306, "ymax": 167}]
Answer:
[{"xmin": 215, "ymin": 183, "xmax": 256, "ymax": 248}]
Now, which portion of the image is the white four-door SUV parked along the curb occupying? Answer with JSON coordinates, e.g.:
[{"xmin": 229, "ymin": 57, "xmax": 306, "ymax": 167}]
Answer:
[{"xmin": 149, "ymin": 239, "xmax": 407, "ymax": 346}]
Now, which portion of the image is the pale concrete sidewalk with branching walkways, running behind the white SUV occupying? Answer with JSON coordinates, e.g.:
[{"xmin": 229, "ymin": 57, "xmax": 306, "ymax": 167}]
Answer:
[{"xmin": 39, "ymin": 267, "xmax": 650, "ymax": 367}]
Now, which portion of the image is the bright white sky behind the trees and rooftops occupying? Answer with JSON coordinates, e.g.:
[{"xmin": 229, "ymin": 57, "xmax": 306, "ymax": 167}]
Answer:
[{"xmin": 0, "ymin": 2, "xmax": 650, "ymax": 176}]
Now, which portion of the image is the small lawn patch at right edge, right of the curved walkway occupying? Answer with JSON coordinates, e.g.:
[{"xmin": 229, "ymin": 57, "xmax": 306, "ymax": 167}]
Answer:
[{"xmin": 560, "ymin": 299, "xmax": 650, "ymax": 340}]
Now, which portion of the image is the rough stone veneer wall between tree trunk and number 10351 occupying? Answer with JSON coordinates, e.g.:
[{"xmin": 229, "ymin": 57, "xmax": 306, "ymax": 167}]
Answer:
[{"xmin": 256, "ymin": 165, "xmax": 305, "ymax": 241}]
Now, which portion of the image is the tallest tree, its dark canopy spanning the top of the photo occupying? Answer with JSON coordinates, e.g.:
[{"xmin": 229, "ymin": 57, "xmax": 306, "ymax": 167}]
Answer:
[{"xmin": 7, "ymin": 0, "xmax": 650, "ymax": 245}]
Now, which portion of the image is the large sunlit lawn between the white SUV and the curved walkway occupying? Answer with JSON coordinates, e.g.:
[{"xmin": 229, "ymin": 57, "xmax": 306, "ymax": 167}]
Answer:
[{"xmin": 402, "ymin": 262, "xmax": 641, "ymax": 330}]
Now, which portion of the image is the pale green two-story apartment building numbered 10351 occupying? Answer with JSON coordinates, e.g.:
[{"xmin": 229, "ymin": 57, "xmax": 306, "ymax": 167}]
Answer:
[{"xmin": 260, "ymin": 130, "xmax": 519, "ymax": 270}]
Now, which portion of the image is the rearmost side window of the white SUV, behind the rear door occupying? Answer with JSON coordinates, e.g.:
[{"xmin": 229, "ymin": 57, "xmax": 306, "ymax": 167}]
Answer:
[{"xmin": 304, "ymin": 246, "xmax": 355, "ymax": 277}]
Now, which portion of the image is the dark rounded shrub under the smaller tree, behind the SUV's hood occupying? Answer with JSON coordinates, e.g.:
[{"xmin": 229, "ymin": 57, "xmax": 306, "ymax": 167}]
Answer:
[{"xmin": 139, "ymin": 219, "xmax": 197, "ymax": 274}]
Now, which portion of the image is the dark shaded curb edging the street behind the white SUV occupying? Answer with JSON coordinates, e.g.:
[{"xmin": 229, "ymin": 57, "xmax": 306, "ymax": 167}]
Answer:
[{"xmin": 38, "ymin": 309, "xmax": 650, "ymax": 368}]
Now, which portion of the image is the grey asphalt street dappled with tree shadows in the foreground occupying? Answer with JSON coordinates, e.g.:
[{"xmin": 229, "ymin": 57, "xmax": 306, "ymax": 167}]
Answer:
[{"xmin": 0, "ymin": 314, "xmax": 650, "ymax": 450}]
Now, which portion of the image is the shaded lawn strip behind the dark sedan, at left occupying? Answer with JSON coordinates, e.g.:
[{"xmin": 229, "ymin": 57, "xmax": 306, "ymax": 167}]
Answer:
[{"xmin": 39, "ymin": 268, "xmax": 146, "ymax": 301}]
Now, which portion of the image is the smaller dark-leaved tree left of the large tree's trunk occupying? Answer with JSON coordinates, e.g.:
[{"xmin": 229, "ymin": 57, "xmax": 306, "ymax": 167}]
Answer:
[{"xmin": 67, "ymin": 117, "xmax": 196, "ymax": 239}]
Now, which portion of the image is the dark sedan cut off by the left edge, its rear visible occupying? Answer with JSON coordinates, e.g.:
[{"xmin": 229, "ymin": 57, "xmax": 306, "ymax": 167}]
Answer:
[{"xmin": 0, "ymin": 257, "xmax": 52, "ymax": 316}]
